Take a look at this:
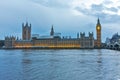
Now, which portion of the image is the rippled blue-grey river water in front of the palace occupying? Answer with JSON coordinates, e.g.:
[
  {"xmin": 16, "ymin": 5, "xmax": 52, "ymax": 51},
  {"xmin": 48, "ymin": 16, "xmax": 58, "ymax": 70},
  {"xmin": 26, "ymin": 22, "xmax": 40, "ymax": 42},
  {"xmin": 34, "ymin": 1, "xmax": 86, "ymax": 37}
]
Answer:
[{"xmin": 0, "ymin": 49, "xmax": 120, "ymax": 80}]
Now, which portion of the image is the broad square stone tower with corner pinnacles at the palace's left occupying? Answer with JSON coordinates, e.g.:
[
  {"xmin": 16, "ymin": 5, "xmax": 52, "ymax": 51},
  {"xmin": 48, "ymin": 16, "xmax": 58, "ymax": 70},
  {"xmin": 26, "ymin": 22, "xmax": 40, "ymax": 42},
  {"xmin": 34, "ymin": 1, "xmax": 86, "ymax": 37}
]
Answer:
[{"xmin": 22, "ymin": 22, "xmax": 31, "ymax": 40}]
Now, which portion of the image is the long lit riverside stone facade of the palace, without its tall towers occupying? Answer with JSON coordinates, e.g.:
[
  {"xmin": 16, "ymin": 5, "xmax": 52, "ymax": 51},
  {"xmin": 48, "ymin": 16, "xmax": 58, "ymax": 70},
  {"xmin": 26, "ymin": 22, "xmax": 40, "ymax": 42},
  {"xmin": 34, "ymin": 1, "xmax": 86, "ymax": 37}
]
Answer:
[{"xmin": 5, "ymin": 33, "xmax": 94, "ymax": 48}]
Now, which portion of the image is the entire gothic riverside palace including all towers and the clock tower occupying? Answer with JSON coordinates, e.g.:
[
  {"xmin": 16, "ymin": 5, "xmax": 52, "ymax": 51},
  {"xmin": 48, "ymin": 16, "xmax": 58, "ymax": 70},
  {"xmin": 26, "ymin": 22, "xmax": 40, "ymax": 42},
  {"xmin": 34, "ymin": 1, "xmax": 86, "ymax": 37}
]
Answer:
[{"xmin": 4, "ymin": 18, "xmax": 101, "ymax": 49}]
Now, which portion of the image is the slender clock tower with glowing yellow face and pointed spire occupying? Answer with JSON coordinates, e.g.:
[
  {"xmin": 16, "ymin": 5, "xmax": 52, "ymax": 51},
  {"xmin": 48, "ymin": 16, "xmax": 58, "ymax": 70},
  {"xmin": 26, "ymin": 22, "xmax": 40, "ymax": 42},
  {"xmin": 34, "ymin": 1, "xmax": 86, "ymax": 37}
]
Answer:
[{"xmin": 96, "ymin": 18, "xmax": 101, "ymax": 48}]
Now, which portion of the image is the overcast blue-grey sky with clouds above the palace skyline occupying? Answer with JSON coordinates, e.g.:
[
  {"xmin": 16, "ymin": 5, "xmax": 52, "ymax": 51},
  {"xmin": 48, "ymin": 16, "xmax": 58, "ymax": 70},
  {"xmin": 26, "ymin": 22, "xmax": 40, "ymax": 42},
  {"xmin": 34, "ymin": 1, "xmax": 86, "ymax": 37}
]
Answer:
[{"xmin": 0, "ymin": 0, "xmax": 120, "ymax": 41}]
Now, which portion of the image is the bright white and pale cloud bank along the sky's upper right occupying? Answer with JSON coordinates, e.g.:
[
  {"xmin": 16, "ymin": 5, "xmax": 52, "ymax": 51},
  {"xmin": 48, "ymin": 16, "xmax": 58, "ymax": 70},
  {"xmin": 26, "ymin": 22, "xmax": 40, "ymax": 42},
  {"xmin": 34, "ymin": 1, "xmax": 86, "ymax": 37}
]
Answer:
[{"xmin": 28, "ymin": 0, "xmax": 120, "ymax": 17}]
